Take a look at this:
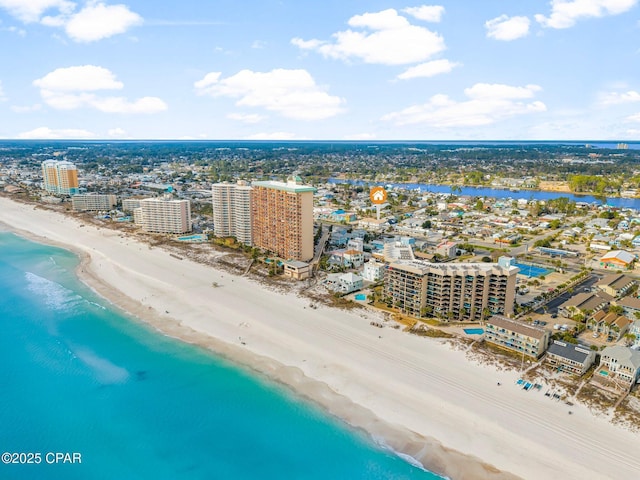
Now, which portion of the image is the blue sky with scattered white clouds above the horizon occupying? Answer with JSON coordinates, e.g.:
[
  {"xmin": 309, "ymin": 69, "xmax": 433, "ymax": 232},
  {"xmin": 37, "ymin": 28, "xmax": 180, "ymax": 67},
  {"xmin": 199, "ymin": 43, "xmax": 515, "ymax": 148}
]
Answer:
[{"xmin": 0, "ymin": 0, "xmax": 640, "ymax": 141}]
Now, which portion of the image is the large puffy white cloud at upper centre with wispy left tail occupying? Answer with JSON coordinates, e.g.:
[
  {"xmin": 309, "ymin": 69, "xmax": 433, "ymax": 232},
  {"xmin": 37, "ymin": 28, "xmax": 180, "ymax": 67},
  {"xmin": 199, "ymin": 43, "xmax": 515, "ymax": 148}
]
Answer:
[{"xmin": 291, "ymin": 8, "xmax": 445, "ymax": 65}]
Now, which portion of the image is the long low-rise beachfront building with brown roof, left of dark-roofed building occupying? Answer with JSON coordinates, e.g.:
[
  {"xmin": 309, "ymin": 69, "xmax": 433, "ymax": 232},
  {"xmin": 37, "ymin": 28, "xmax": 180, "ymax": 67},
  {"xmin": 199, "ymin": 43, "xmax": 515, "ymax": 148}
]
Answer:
[{"xmin": 484, "ymin": 315, "xmax": 551, "ymax": 359}]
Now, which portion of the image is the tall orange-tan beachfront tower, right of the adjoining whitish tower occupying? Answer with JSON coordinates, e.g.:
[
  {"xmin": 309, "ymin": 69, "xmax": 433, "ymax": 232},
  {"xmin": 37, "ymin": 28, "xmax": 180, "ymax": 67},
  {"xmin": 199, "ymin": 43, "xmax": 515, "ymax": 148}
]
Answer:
[{"xmin": 251, "ymin": 177, "xmax": 315, "ymax": 261}]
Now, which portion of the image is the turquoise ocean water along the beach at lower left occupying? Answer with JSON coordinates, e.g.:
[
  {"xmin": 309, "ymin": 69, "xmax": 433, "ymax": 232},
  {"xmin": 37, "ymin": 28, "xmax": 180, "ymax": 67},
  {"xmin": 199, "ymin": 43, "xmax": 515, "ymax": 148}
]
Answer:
[{"xmin": 0, "ymin": 232, "xmax": 440, "ymax": 480}]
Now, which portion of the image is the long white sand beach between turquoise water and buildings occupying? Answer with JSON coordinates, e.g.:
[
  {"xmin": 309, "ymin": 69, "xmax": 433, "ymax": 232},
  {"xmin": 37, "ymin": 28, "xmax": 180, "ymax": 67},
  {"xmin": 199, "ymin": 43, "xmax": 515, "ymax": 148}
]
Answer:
[{"xmin": 0, "ymin": 198, "xmax": 640, "ymax": 480}]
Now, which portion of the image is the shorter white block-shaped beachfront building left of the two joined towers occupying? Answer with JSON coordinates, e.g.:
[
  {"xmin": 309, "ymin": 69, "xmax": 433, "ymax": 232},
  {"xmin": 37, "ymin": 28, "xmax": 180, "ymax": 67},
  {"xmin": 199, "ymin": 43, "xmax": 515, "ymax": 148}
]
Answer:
[{"xmin": 133, "ymin": 198, "xmax": 191, "ymax": 233}]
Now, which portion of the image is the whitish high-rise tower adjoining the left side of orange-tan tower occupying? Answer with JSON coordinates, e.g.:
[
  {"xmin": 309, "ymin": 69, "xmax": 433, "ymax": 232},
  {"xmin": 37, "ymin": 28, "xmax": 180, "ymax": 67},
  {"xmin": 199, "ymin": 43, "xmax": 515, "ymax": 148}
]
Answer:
[{"xmin": 211, "ymin": 181, "xmax": 253, "ymax": 245}]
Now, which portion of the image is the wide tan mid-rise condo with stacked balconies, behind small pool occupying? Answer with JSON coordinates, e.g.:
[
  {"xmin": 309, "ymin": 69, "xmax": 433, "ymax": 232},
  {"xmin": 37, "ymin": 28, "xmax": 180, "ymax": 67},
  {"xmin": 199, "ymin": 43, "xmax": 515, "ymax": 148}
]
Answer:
[{"xmin": 384, "ymin": 260, "xmax": 519, "ymax": 321}]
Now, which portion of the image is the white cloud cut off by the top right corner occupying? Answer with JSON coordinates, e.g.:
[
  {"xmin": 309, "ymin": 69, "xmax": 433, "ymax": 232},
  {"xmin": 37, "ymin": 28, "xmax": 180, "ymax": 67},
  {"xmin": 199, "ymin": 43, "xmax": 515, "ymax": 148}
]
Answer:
[{"xmin": 535, "ymin": 0, "xmax": 638, "ymax": 28}]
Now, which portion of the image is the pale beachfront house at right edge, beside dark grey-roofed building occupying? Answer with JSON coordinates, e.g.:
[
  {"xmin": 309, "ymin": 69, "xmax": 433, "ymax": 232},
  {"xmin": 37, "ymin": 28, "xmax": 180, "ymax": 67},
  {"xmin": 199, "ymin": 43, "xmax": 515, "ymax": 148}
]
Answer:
[{"xmin": 594, "ymin": 345, "xmax": 640, "ymax": 390}]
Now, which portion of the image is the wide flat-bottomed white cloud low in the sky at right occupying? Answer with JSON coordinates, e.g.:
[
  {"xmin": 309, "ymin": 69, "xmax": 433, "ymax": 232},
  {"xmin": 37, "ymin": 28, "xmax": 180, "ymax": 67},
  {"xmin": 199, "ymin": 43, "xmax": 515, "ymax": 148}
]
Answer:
[{"xmin": 382, "ymin": 83, "xmax": 547, "ymax": 127}]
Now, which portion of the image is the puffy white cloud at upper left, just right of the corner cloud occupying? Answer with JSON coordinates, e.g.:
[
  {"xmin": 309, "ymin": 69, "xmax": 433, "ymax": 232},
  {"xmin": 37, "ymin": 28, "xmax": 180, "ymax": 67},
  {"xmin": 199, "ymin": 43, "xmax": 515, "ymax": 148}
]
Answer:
[{"xmin": 65, "ymin": 2, "xmax": 142, "ymax": 42}]
